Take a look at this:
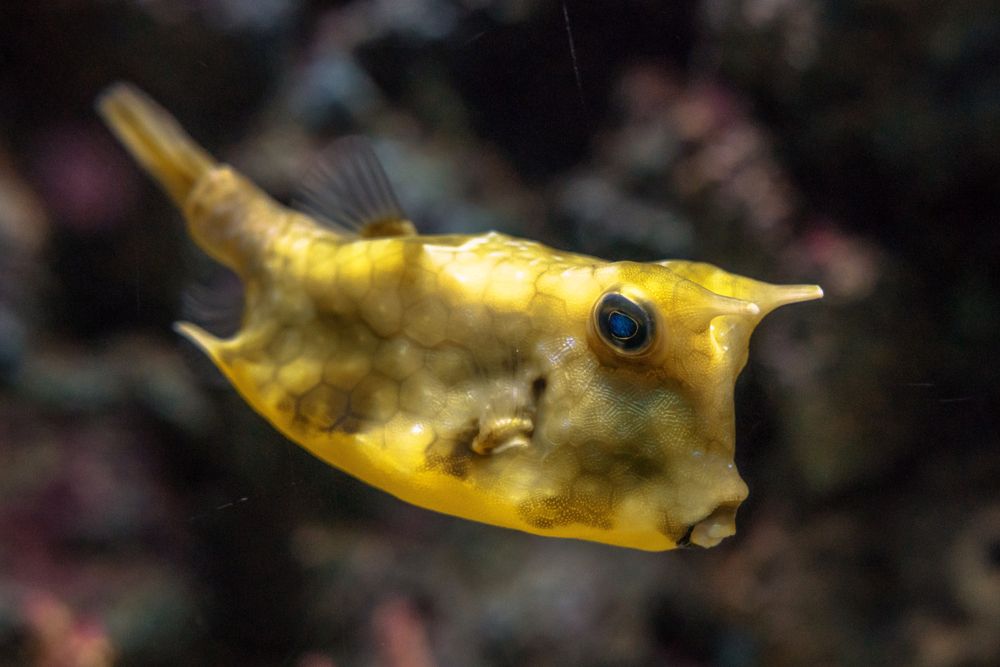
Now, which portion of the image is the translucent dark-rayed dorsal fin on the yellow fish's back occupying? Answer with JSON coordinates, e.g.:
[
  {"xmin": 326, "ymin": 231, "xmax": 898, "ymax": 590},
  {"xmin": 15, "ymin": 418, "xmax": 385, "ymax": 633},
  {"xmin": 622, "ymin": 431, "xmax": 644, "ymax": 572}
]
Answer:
[{"xmin": 296, "ymin": 137, "xmax": 416, "ymax": 238}]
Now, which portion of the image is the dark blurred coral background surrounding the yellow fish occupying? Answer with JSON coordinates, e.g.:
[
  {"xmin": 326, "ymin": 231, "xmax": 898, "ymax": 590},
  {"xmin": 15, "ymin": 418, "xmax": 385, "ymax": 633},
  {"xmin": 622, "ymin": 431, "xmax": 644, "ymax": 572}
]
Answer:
[{"xmin": 0, "ymin": 0, "xmax": 1000, "ymax": 667}]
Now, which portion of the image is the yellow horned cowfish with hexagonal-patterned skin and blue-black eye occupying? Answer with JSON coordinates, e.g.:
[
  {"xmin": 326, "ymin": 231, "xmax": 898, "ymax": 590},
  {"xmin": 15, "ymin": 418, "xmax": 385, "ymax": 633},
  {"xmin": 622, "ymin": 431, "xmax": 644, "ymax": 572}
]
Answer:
[{"xmin": 97, "ymin": 83, "xmax": 823, "ymax": 551}]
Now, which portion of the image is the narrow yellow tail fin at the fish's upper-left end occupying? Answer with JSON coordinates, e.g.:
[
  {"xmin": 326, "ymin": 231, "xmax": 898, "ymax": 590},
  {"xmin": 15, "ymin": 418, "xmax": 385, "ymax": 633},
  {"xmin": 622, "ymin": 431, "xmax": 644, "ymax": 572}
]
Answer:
[{"xmin": 97, "ymin": 83, "xmax": 216, "ymax": 206}]
